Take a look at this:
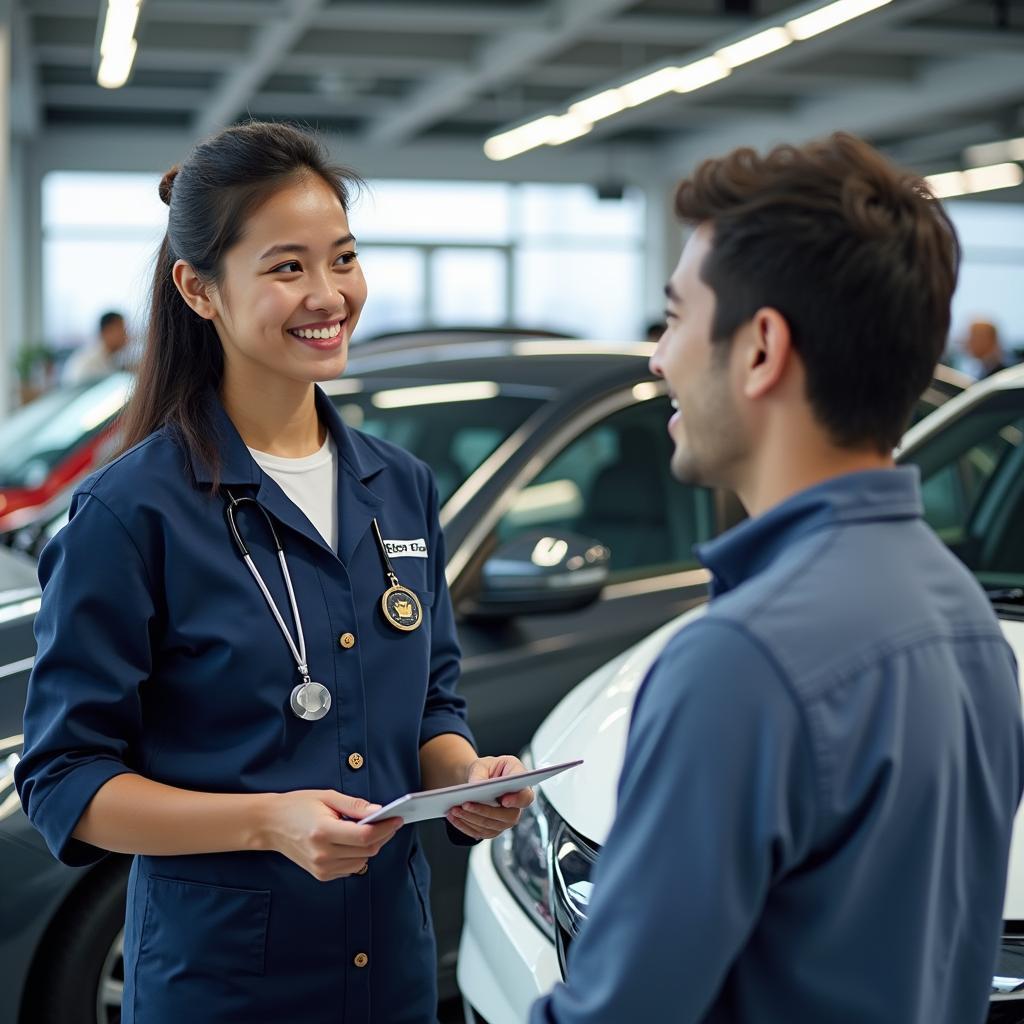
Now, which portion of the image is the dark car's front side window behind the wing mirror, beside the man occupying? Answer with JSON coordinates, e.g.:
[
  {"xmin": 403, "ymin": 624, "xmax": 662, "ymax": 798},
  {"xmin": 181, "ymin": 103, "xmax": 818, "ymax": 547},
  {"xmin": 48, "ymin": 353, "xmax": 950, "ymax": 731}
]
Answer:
[{"xmin": 498, "ymin": 397, "xmax": 714, "ymax": 578}]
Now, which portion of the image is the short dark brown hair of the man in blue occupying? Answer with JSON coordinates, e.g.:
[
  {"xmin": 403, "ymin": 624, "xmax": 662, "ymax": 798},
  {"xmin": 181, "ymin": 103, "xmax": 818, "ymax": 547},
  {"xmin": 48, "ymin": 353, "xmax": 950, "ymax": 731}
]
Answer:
[{"xmin": 676, "ymin": 132, "xmax": 959, "ymax": 452}]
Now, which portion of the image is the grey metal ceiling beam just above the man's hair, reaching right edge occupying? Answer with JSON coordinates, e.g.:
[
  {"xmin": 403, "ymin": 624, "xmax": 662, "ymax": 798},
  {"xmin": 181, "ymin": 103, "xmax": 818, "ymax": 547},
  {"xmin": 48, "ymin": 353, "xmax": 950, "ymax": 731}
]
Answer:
[{"xmin": 669, "ymin": 53, "xmax": 1024, "ymax": 172}]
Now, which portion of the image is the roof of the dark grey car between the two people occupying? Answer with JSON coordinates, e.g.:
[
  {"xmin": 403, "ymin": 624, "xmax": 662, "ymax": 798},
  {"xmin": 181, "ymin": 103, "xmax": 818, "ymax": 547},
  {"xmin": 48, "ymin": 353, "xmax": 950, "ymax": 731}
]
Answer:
[{"xmin": 331, "ymin": 338, "xmax": 654, "ymax": 397}]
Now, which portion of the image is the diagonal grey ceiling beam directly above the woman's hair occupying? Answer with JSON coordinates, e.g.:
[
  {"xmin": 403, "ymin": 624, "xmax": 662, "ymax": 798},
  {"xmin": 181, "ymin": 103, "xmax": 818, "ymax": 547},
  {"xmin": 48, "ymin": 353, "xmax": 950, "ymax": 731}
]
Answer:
[{"xmin": 194, "ymin": 0, "xmax": 326, "ymax": 135}]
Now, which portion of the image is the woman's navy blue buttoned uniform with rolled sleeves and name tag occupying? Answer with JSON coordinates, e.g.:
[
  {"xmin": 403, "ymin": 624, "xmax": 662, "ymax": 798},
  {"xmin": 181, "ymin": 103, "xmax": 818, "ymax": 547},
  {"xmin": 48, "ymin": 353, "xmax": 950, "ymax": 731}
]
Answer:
[{"xmin": 16, "ymin": 388, "xmax": 472, "ymax": 1024}]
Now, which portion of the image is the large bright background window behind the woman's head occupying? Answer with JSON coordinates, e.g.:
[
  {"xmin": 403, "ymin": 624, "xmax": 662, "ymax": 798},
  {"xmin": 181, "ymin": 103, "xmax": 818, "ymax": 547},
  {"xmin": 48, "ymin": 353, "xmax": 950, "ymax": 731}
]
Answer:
[{"xmin": 43, "ymin": 172, "xmax": 644, "ymax": 347}]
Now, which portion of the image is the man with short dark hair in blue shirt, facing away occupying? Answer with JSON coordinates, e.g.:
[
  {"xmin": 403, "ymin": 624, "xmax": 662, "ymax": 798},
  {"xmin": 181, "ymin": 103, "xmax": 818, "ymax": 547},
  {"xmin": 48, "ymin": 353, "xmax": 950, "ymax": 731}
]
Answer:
[{"xmin": 531, "ymin": 134, "xmax": 1024, "ymax": 1024}]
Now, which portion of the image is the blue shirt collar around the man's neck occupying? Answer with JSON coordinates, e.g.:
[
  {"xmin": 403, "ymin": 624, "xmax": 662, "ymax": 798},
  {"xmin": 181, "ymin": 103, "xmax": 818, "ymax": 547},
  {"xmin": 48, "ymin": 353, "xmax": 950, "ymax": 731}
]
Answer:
[{"xmin": 696, "ymin": 466, "xmax": 924, "ymax": 597}]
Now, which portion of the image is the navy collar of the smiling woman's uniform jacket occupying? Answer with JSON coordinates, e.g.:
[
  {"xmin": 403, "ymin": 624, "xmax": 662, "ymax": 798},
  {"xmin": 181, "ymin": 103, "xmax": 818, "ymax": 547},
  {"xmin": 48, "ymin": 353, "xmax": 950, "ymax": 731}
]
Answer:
[{"xmin": 190, "ymin": 387, "xmax": 385, "ymax": 486}]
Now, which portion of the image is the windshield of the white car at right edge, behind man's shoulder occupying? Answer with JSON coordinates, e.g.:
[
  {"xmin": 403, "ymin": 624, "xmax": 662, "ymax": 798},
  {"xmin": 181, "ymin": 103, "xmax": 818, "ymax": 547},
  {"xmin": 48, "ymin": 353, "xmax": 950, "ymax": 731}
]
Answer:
[{"xmin": 902, "ymin": 389, "xmax": 1024, "ymax": 593}]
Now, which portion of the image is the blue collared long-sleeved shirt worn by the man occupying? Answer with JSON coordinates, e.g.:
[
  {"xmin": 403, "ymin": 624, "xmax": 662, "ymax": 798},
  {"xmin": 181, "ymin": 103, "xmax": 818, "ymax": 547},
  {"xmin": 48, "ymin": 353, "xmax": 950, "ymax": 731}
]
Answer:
[{"xmin": 531, "ymin": 468, "xmax": 1024, "ymax": 1024}]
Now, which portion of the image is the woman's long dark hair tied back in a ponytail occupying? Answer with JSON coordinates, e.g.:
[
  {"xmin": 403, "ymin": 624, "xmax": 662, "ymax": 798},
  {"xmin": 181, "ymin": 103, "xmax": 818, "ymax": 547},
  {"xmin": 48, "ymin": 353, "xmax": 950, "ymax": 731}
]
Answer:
[{"xmin": 118, "ymin": 122, "xmax": 361, "ymax": 489}]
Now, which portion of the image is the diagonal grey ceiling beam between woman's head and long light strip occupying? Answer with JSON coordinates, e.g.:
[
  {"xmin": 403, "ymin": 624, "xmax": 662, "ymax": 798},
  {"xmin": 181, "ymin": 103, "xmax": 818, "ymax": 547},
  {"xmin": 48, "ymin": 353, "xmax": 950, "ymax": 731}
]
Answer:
[{"xmin": 367, "ymin": 0, "xmax": 635, "ymax": 144}]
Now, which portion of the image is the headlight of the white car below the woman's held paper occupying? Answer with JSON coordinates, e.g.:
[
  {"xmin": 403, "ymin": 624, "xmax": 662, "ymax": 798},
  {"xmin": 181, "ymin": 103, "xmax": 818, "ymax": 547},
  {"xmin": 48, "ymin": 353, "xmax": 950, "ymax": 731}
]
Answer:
[{"xmin": 490, "ymin": 750, "xmax": 561, "ymax": 942}]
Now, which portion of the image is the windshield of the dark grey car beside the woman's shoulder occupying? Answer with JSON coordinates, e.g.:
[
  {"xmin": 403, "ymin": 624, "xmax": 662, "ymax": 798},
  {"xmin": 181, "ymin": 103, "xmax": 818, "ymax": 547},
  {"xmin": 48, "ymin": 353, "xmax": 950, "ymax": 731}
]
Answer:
[{"xmin": 331, "ymin": 380, "xmax": 544, "ymax": 505}]
